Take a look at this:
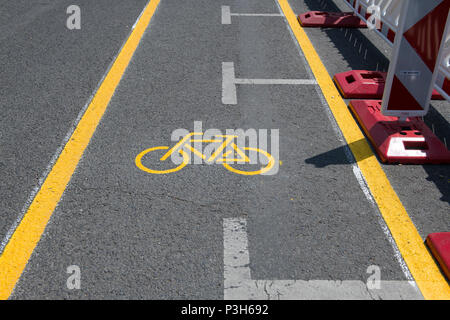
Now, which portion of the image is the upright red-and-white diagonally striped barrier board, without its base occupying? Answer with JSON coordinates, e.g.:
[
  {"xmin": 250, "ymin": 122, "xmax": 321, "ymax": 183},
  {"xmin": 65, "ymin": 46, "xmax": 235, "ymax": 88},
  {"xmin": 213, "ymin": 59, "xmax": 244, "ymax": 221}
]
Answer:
[{"xmin": 382, "ymin": 0, "xmax": 450, "ymax": 119}]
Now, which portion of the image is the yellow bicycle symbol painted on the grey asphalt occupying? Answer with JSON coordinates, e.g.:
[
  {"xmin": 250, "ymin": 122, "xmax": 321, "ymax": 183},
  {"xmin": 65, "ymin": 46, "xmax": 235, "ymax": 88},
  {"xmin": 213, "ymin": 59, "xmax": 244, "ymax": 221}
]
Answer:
[{"xmin": 135, "ymin": 132, "xmax": 275, "ymax": 175}]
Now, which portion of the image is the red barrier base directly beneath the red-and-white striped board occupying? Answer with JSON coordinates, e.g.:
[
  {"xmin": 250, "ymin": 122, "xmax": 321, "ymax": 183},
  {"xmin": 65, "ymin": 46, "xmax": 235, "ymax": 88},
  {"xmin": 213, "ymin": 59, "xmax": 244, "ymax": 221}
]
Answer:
[{"xmin": 349, "ymin": 100, "xmax": 450, "ymax": 164}]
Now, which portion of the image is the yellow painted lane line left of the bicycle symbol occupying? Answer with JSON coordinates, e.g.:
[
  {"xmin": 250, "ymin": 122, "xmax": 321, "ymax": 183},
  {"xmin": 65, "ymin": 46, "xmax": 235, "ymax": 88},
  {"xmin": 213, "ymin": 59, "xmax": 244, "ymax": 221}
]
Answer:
[{"xmin": 0, "ymin": 0, "xmax": 160, "ymax": 300}]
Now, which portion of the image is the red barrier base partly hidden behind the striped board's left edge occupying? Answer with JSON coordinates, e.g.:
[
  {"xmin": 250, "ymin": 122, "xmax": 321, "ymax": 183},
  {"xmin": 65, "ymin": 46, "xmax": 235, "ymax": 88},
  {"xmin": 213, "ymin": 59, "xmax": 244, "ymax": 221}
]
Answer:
[{"xmin": 333, "ymin": 70, "xmax": 445, "ymax": 100}]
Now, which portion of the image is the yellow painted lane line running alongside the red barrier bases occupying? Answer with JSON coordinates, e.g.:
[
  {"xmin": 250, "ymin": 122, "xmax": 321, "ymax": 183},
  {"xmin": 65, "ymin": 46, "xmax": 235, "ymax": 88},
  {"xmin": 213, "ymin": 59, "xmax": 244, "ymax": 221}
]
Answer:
[{"xmin": 277, "ymin": 0, "xmax": 450, "ymax": 299}]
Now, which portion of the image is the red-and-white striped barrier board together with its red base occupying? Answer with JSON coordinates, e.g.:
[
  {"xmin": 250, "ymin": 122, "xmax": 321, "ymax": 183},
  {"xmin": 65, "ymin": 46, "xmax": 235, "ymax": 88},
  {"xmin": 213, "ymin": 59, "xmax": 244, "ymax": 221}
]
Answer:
[{"xmin": 350, "ymin": 0, "xmax": 450, "ymax": 164}]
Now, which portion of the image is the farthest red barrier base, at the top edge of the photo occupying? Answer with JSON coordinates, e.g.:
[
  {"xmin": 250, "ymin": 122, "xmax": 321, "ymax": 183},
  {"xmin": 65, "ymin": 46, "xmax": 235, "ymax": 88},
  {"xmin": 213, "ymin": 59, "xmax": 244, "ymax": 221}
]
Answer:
[{"xmin": 297, "ymin": 11, "xmax": 367, "ymax": 28}]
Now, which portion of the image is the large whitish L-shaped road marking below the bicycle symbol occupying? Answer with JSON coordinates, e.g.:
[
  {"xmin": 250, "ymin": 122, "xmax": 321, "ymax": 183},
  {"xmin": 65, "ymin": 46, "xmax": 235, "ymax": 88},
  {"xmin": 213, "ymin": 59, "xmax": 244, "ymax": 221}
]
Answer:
[{"xmin": 223, "ymin": 218, "xmax": 423, "ymax": 300}]
